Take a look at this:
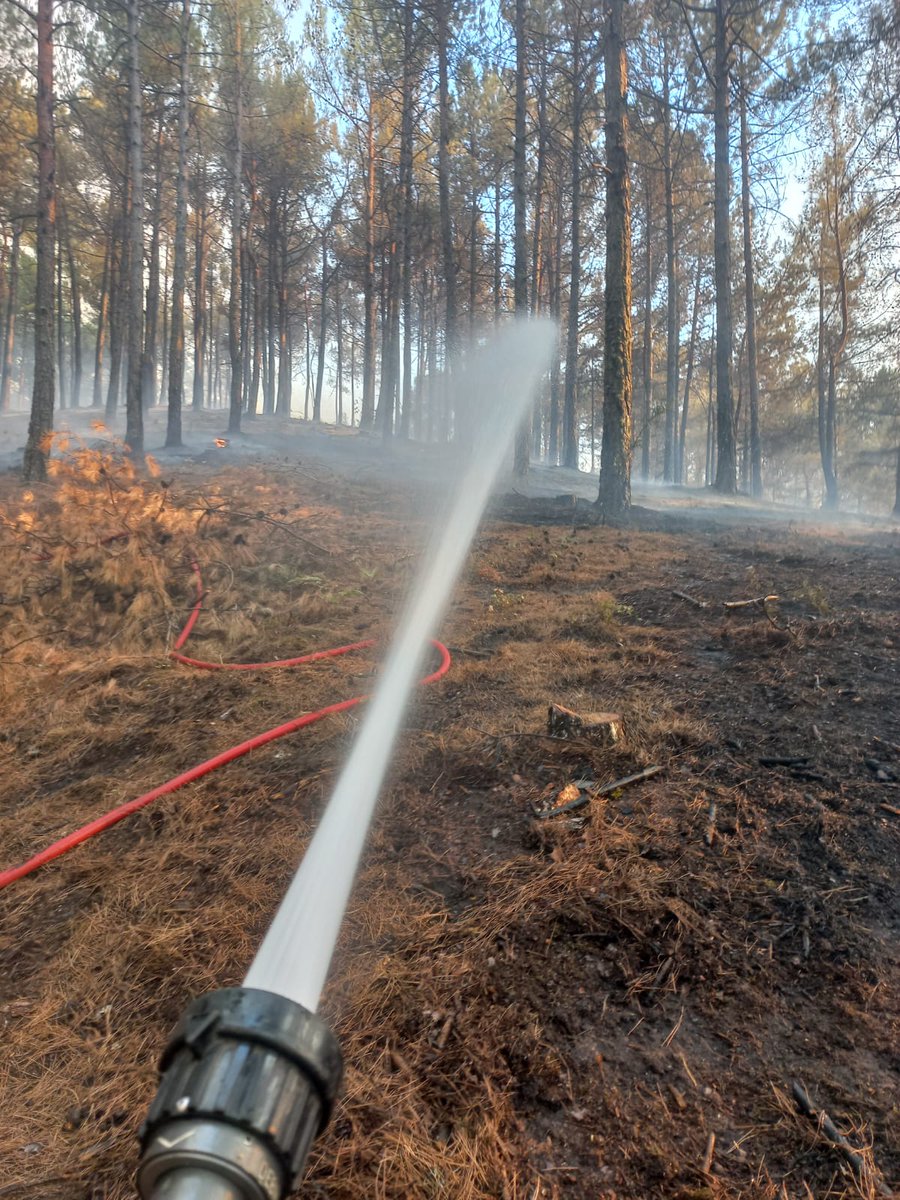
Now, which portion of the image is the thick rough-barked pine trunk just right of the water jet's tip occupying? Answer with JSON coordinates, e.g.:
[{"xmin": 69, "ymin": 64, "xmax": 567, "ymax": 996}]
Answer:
[{"xmin": 596, "ymin": 0, "xmax": 631, "ymax": 521}]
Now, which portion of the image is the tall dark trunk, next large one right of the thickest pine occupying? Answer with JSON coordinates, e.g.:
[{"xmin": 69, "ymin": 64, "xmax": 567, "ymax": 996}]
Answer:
[{"xmin": 713, "ymin": 0, "xmax": 737, "ymax": 496}]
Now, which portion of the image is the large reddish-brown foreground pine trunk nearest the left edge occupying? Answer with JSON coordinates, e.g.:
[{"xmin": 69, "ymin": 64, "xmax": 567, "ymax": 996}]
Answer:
[{"xmin": 23, "ymin": 0, "xmax": 56, "ymax": 480}]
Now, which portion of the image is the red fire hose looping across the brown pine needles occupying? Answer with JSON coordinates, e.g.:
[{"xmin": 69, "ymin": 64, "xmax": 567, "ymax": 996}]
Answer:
[{"xmin": 0, "ymin": 563, "xmax": 450, "ymax": 888}]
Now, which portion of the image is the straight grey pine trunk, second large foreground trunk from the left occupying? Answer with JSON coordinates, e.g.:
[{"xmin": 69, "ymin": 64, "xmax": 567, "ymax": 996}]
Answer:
[{"xmin": 125, "ymin": 0, "xmax": 144, "ymax": 456}]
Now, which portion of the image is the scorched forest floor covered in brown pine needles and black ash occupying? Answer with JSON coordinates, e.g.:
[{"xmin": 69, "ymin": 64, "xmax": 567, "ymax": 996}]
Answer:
[{"xmin": 0, "ymin": 416, "xmax": 900, "ymax": 1200}]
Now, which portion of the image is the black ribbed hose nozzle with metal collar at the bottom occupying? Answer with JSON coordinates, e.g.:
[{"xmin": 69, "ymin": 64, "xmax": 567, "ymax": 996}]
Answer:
[{"xmin": 138, "ymin": 988, "xmax": 343, "ymax": 1200}]
